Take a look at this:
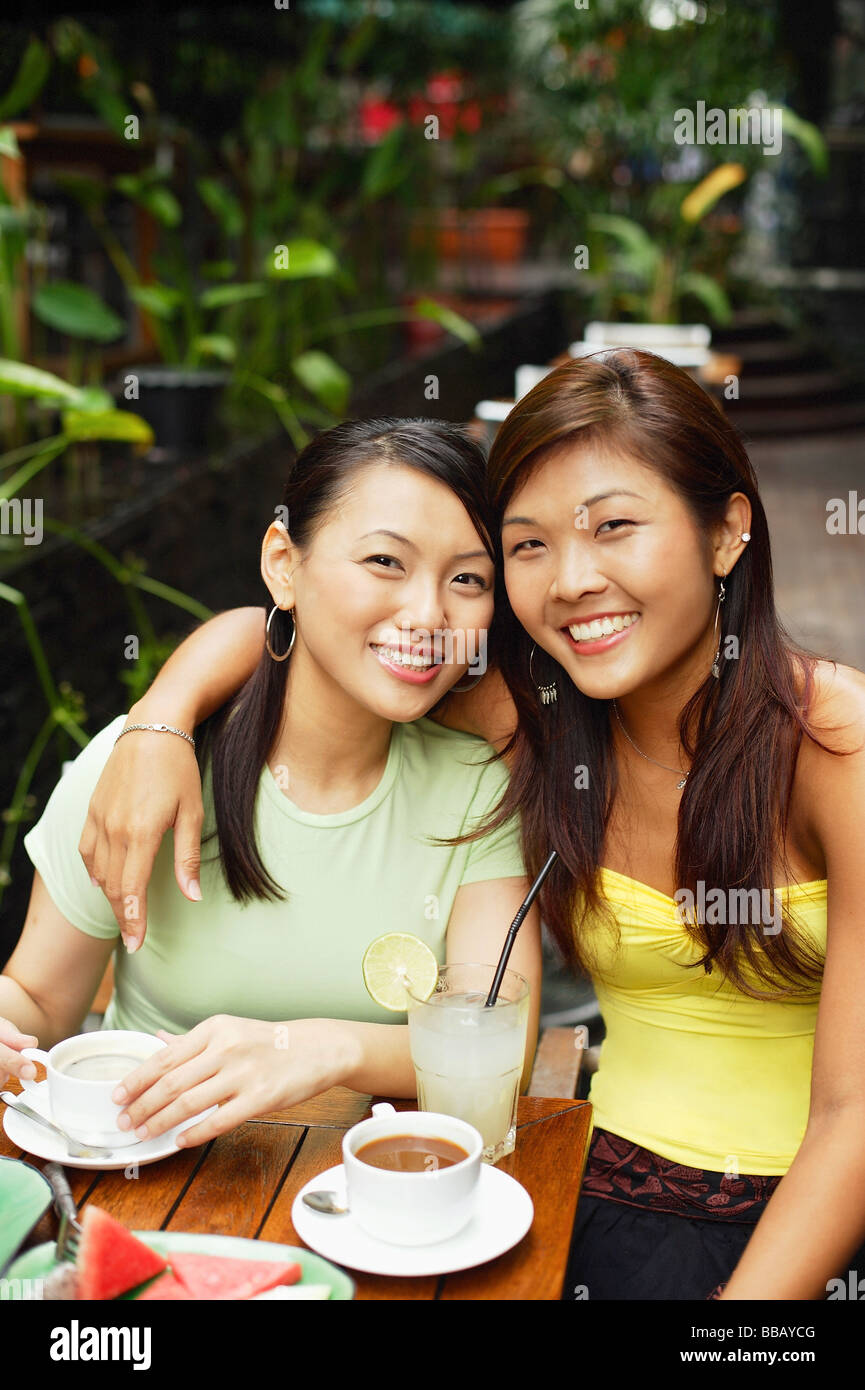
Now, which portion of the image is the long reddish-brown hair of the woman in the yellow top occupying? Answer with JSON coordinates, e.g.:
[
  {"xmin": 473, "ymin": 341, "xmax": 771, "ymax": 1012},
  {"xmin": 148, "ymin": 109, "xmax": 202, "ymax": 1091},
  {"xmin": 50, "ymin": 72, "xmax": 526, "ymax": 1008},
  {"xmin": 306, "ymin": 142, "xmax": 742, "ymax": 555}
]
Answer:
[{"xmin": 484, "ymin": 349, "xmax": 839, "ymax": 998}]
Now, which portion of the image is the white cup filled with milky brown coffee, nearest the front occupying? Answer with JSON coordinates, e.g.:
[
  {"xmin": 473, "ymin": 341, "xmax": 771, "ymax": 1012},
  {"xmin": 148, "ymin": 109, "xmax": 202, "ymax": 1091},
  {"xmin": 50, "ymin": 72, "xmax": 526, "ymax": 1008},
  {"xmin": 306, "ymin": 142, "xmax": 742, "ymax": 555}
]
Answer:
[{"xmin": 342, "ymin": 1104, "xmax": 484, "ymax": 1245}]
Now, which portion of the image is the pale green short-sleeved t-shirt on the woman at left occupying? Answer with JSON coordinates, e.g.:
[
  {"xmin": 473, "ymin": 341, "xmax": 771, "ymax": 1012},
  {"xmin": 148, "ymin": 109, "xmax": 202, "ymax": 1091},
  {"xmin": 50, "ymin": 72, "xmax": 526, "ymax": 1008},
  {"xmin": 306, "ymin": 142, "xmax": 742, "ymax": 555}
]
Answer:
[{"xmin": 24, "ymin": 714, "xmax": 524, "ymax": 1033}]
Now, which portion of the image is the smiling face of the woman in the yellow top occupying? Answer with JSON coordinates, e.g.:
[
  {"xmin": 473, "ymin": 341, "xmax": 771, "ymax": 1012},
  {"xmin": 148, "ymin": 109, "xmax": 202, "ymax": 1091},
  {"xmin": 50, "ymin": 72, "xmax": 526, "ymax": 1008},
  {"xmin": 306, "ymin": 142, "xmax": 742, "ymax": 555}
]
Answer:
[{"xmin": 502, "ymin": 445, "xmax": 722, "ymax": 699}]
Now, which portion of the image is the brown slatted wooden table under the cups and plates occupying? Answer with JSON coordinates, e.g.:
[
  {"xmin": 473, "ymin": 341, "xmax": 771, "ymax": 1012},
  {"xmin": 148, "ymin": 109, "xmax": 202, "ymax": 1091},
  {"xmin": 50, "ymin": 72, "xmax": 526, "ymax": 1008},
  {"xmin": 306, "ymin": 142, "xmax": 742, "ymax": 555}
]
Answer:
[{"xmin": 0, "ymin": 1079, "xmax": 591, "ymax": 1300}]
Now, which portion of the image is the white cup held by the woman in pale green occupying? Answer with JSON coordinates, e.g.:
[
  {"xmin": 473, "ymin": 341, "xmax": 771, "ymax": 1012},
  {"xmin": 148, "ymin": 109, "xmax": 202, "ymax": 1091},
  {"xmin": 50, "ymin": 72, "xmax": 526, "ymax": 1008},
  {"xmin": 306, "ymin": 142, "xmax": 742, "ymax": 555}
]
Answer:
[{"xmin": 21, "ymin": 1029, "xmax": 167, "ymax": 1148}]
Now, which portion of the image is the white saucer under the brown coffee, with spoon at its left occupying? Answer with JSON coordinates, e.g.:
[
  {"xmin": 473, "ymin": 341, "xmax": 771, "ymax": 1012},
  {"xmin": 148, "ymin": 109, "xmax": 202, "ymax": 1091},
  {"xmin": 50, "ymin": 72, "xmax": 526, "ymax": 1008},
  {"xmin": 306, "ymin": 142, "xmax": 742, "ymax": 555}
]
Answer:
[{"xmin": 291, "ymin": 1163, "xmax": 534, "ymax": 1276}]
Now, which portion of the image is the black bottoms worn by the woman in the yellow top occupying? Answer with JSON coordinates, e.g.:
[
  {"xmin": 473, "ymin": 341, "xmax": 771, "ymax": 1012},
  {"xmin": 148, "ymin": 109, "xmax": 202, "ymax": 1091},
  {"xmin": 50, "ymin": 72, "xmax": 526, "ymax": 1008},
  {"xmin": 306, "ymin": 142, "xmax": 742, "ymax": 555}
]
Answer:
[{"xmin": 562, "ymin": 1195, "xmax": 865, "ymax": 1302}]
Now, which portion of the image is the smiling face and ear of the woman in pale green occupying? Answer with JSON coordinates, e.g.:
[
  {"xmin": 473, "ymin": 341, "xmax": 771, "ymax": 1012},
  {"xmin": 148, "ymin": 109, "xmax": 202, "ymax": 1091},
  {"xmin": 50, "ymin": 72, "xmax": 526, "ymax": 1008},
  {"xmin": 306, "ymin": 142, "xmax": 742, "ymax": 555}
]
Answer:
[{"xmin": 261, "ymin": 463, "xmax": 495, "ymax": 723}]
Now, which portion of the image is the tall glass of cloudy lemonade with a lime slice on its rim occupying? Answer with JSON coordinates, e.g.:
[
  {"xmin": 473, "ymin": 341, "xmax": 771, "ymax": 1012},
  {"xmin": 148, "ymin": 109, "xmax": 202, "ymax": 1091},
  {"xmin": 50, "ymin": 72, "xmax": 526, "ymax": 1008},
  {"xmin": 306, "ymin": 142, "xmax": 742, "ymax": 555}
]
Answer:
[{"xmin": 407, "ymin": 965, "xmax": 528, "ymax": 1163}]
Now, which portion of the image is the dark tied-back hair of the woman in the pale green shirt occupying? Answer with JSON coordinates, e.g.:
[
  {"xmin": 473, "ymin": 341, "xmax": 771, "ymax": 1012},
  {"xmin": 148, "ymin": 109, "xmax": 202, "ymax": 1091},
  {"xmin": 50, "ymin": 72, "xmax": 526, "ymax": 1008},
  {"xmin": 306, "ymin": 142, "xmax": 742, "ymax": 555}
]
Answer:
[{"xmin": 196, "ymin": 417, "xmax": 499, "ymax": 902}]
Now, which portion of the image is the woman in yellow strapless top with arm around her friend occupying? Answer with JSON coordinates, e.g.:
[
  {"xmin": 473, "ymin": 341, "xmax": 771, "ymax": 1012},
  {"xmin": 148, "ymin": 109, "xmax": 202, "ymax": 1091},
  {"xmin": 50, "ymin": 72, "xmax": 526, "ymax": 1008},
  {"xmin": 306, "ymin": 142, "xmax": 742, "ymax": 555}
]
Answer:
[{"xmin": 74, "ymin": 350, "xmax": 865, "ymax": 1300}]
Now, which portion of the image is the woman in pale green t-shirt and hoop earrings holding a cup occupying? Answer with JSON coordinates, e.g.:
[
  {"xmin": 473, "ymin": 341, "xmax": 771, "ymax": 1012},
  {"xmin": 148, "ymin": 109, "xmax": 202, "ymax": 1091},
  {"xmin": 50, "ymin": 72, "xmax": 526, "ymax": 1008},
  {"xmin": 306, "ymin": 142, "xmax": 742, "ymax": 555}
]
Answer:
[{"xmin": 0, "ymin": 420, "xmax": 541, "ymax": 1144}]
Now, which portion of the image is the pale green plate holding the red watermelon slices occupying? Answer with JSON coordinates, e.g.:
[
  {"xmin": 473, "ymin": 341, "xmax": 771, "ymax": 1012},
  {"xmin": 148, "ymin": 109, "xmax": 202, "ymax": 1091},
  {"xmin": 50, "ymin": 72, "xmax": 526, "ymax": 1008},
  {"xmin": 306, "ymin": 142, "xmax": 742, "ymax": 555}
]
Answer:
[{"xmin": 6, "ymin": 1228, "xmax": 355, "ymax": 1302}]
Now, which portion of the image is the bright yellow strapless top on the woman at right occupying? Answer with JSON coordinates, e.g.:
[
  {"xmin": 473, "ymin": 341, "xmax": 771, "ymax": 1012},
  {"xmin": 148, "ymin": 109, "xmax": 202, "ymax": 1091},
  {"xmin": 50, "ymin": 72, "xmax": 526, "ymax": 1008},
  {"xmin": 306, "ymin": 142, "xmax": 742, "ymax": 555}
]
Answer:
[{"xmin": 583, "ymin": 869, "xmax": 826, "ymax": 1175}]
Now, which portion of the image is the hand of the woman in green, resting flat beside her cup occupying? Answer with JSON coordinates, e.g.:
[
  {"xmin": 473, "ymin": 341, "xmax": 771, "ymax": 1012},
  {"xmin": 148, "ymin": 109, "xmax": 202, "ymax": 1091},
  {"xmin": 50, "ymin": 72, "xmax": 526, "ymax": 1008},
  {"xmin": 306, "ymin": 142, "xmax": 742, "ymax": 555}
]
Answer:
[{"xmin": 114, "ymin": 1013, "xmax": 349, "ymax": 1147}]
